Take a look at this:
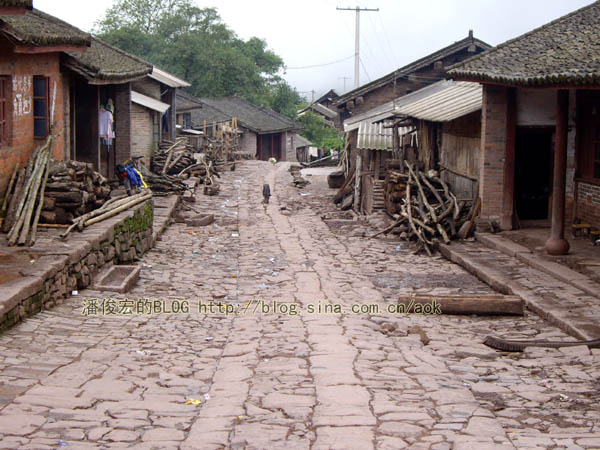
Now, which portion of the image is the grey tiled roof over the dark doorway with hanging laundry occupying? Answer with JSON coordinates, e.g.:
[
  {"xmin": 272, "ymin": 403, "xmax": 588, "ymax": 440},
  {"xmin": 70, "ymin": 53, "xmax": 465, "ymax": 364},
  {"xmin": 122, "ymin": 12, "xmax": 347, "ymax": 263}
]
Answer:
[{"xmin": 65, "ymin": 38, "xmax": 152, "ymax": 83}]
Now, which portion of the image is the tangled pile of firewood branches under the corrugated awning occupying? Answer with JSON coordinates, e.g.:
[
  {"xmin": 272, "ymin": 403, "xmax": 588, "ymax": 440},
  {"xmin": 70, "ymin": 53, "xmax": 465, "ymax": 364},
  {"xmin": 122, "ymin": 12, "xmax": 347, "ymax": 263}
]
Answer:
[{"xmin": 373, "ymin": 162, "xmax": 475, "ymax": 255}]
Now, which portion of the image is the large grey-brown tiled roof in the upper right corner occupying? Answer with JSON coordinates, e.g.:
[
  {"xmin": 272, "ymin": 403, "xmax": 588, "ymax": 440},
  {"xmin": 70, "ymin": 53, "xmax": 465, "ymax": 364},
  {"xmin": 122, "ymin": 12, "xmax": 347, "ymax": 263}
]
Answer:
[{"xmin": 447, "ymin": 2, "xmax": 600, "ymax": 86}]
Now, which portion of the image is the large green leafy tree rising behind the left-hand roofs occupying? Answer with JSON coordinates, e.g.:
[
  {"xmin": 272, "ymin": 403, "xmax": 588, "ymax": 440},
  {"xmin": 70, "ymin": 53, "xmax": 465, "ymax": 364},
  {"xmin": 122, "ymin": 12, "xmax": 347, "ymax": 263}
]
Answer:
[{"xmin": 94, "ymin": 0, "xmax": 301, "ymax": 118}]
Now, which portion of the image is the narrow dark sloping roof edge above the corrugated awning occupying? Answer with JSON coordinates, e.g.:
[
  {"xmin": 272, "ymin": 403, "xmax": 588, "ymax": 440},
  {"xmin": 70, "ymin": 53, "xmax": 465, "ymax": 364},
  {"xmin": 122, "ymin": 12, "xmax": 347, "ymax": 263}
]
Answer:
[{"xmin": 333, "ymin": 32, "xmax": 491, "ymax": 106}]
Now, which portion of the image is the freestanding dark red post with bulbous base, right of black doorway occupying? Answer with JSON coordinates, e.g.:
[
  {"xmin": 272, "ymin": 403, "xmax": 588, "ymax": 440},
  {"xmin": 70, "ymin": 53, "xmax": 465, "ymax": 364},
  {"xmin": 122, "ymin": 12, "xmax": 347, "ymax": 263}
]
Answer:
[{"xmin": 546, "ymin": 89, "xmax": 569, "ymax": 255}]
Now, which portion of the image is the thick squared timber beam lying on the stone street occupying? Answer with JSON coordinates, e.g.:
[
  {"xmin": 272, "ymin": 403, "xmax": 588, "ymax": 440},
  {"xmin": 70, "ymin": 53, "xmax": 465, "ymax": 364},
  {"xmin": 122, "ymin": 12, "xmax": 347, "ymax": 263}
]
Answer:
[{"xmin": 397, "ymin": 294, "xmax": 523, "ymax": 316}]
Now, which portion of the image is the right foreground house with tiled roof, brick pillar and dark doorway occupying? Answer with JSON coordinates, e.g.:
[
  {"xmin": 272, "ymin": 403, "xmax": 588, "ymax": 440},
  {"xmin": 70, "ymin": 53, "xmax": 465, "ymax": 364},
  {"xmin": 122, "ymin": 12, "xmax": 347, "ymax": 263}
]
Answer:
[{"xmin": 448, "ymin": 2, "xmax": 600, "ymax": 254}]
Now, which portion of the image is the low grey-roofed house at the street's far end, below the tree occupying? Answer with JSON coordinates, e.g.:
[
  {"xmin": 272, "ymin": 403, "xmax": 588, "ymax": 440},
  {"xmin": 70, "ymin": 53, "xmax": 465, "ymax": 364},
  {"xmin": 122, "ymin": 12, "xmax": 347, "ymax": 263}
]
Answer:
[{"xmin": 177, "ymin": 93, "xmax": 300, "ymax": 161}]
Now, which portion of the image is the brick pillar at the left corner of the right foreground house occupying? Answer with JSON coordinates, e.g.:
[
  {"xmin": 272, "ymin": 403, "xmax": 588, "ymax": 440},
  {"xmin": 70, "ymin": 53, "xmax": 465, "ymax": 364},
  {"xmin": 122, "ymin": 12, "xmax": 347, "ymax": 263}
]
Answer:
[{"xmin": 479, "ymin": 85, "xmax": 508, "ymax": 222}]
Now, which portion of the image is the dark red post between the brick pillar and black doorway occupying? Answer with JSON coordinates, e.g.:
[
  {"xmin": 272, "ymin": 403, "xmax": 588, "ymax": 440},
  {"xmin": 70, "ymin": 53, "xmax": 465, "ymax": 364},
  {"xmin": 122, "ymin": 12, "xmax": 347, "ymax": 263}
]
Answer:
[{"xmin": 500, "ymin": 88, "xmax": 517, "ymax": 230}]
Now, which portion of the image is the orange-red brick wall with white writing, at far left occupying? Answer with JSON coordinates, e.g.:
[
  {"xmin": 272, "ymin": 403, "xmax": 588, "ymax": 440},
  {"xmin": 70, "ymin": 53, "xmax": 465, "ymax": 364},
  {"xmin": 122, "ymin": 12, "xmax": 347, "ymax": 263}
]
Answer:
[{"xmin": 0, "ymin": 47, "xmax": 69, "ymax": 196}]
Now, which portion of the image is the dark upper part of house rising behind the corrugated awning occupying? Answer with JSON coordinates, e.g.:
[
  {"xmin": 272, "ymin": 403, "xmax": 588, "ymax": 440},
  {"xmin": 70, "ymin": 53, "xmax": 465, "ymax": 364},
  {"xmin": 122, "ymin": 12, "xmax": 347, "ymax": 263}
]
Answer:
[{"xmin": 332, "ymin": 31, "xmax": 491, "ymax": 156}]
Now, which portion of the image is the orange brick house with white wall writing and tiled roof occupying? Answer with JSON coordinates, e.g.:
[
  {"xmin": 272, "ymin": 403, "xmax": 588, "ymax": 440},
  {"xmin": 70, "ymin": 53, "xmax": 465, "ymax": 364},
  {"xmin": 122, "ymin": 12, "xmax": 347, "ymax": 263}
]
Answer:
[{"xmin": 0, "ymin": 0, "xmax": 91, "ymax": 192}]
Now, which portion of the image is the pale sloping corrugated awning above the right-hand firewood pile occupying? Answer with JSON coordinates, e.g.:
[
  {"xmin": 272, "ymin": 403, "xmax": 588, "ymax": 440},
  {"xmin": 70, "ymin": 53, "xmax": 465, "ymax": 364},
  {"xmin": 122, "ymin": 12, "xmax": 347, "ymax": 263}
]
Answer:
[{"xmin": 394, "ymin": 80, "xmax": 483, "ymax": 122}]
